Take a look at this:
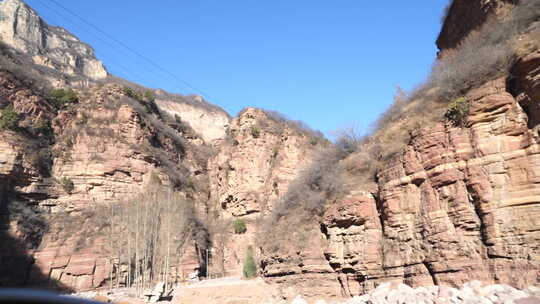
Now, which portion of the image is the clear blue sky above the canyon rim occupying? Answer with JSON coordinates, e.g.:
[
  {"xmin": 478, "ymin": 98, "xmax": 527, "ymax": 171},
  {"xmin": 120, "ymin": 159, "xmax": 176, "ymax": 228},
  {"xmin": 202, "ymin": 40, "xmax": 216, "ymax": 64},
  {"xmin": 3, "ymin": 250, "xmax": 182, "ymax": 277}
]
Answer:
[{"xmin": 27, "ymin": 0, "xmax": 448, "ymax": 134}]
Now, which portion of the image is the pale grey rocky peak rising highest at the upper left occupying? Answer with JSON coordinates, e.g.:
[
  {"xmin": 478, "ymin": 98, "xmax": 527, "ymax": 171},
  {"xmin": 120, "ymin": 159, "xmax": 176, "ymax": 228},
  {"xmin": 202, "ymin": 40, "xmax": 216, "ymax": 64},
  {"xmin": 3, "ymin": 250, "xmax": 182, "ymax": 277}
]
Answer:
[{"xmin": 0, "ymin": 0, "xmax": 107, "ymax": 80}]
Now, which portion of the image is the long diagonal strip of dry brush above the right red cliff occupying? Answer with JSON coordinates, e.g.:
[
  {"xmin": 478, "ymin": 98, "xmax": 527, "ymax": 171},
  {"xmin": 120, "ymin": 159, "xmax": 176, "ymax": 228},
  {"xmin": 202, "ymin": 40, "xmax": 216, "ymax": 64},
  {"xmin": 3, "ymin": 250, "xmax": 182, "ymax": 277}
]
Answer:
[{"xmin": 259, "ymin": 0, "xmax": 540, "ymax": 253}]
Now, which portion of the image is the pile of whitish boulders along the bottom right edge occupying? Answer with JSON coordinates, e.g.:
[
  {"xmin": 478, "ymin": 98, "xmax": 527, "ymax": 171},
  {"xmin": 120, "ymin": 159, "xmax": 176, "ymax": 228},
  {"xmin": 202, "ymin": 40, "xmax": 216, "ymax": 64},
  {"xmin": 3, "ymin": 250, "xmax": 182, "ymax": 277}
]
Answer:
[{"xmin": 291, "ymin": 281, "xmax": 540, "ymax": 304}]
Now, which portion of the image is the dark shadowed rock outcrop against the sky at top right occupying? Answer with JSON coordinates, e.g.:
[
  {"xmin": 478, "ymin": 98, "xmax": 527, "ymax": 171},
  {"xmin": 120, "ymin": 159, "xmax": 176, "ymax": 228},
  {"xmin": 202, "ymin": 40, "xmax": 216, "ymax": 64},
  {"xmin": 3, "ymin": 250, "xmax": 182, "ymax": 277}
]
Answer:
[{"xmin": 437, "ymin": 0, "xmax": 519, "ymax": 51}]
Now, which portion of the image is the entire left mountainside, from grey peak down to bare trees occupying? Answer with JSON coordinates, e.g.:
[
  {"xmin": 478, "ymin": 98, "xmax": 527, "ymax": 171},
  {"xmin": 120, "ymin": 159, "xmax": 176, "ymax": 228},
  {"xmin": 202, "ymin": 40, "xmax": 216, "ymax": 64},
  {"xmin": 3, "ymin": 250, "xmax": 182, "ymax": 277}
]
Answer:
[{"xmin": 0, "ymin": 0, "xmax": 229, "ymax": 290}]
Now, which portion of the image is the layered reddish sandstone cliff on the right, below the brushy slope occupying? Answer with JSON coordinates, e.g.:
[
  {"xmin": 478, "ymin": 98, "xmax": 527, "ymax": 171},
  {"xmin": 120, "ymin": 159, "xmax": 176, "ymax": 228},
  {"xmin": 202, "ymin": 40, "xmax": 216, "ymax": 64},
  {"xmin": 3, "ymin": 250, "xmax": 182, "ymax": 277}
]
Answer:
[{"xmin": 264, "ymin": 52, "xmax": 540, "ymax": 296}]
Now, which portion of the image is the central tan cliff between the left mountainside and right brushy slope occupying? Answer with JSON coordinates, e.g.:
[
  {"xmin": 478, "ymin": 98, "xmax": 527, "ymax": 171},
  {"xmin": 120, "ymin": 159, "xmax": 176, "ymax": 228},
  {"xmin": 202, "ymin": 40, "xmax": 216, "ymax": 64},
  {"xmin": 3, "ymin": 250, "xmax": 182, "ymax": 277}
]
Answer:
[{"xmin": 208, "ymin": 108, "xmax": 318, "ymax": 275}]
